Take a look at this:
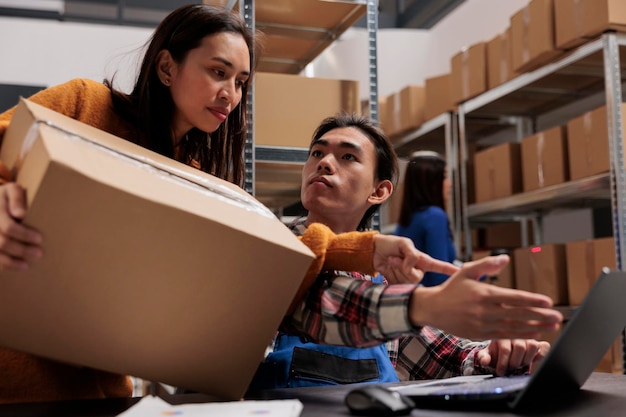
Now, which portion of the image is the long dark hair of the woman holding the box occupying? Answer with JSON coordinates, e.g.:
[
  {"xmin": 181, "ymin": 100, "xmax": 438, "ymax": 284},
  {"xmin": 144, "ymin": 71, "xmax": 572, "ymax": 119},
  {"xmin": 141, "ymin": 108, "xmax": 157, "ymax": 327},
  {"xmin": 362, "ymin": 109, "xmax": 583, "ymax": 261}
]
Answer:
[{"xmin": 105, "ymin": 4, "xmax": 260, "ymax": 185}]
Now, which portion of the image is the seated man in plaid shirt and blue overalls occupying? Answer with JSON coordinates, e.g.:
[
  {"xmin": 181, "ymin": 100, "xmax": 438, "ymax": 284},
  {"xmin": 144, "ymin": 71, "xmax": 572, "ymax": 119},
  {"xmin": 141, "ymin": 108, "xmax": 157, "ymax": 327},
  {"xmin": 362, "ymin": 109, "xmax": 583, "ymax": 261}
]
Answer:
[{"xmin": 251, "ymin": 111, "xmax": 562, "ymax": 392}]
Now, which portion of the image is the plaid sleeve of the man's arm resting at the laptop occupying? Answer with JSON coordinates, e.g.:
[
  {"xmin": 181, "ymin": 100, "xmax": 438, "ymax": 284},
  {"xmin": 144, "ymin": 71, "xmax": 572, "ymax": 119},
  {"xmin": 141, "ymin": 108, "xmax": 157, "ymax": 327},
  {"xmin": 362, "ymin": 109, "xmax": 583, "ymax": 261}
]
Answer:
[{"xmin": 396, "ymin": 327, "xmax": 491, "ymax": 381}]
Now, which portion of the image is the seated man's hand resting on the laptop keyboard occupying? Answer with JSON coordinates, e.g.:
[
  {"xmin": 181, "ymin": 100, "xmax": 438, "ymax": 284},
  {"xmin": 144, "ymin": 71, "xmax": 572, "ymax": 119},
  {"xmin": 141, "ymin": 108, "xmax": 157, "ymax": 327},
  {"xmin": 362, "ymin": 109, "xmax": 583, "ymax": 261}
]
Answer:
[{"xmin": 477, "ymin": 339, "xmax": 550, "ymax": 376}]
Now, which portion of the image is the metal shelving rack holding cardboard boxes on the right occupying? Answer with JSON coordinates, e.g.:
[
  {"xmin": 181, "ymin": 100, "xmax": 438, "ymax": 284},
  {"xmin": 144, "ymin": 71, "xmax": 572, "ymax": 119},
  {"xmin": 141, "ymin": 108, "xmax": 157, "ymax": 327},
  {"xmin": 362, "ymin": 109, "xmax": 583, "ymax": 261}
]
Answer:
[{"xmin": 458, "ymin": 32, "xmax": 626, "ymax": 373}]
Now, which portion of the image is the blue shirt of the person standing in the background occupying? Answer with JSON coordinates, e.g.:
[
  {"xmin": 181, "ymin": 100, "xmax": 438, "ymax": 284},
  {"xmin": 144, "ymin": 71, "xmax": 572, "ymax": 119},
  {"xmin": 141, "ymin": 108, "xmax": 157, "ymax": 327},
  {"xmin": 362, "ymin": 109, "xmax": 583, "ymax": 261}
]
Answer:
[{"xmin": 394, "ymin": 206, "xmax": 456, "ymax": 287}]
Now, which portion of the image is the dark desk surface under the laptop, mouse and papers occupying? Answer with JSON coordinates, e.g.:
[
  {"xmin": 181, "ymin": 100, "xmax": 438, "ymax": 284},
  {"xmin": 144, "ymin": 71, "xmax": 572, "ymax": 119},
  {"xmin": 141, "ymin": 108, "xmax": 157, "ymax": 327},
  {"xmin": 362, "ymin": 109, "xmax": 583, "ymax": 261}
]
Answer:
[{"xmin": 0, "ymin": 373, "xmax": 626, "ymax": 417}]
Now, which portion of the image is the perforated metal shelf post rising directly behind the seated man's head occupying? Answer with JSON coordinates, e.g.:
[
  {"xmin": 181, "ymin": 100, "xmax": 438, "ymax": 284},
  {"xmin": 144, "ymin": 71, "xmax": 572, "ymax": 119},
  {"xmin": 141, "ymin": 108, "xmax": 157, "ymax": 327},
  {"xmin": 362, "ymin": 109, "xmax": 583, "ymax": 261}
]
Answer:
[{"xmin": 366, "ymin": 0, "xmax": 380, "ymax": 230}]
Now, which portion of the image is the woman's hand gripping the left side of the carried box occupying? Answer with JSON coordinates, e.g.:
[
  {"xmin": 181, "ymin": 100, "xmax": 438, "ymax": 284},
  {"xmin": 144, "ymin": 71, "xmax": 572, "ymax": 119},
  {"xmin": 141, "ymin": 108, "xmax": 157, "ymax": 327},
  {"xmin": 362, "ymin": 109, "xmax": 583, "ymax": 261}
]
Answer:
[{"xmin": 0, "ymin": 182, "xmax": 43, "ymax": 271}]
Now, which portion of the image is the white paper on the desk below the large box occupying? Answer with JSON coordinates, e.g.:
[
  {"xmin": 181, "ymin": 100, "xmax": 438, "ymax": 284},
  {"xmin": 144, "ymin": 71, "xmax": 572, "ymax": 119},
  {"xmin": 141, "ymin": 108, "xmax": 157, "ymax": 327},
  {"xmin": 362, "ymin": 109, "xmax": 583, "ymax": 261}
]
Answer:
[{"xmin": 118, "ymin": 396, "xmax": 302, "ymax": 417}]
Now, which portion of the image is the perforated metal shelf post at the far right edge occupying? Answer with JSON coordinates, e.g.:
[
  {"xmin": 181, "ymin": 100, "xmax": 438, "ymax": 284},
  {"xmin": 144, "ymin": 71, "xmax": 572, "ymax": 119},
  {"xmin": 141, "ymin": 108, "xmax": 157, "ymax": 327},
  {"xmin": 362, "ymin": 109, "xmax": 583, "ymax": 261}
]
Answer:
[{"xmin": 602, "ymin": 32, "xmax": 626, "ymax": 374}]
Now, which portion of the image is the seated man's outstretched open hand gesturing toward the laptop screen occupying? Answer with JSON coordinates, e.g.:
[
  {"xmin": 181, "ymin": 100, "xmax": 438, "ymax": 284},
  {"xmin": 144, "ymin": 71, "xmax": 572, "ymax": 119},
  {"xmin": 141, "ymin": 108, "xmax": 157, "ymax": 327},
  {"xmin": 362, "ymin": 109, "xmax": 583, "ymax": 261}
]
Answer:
[{"xmin": 409, "ymin": 255, "xmax": 563, "ymax": 340}]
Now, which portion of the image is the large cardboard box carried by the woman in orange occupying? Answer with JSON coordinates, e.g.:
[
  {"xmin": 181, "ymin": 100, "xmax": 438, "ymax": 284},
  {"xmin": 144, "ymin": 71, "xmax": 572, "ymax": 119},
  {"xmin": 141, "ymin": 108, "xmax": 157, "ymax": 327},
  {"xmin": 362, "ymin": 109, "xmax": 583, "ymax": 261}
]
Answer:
[{"xmin": 0, "ymin": 100, "xmax": 313, "ymax": 399}]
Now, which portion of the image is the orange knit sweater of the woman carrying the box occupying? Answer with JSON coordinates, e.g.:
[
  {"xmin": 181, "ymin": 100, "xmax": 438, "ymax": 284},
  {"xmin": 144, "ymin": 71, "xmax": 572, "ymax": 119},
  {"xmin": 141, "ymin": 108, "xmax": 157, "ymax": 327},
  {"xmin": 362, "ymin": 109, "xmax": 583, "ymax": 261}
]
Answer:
[{"xmin": 0, "ymin": 79, "xmax": 376, "ymax": 403}]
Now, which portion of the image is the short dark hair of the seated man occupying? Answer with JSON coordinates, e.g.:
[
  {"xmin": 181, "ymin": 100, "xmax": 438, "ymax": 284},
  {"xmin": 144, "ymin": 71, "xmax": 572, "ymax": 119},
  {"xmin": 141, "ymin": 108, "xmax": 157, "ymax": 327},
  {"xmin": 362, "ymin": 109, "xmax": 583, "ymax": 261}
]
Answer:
[{"xmin": 309, "ymin": 113, "xmax": 398, "ymax": 231}]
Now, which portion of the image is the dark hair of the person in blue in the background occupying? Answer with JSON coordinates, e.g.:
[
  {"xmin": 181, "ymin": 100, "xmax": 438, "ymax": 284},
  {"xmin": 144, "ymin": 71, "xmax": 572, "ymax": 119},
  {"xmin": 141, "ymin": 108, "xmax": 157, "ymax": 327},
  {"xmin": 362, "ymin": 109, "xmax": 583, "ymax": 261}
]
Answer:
[{"xmin": 398, "ymin": 151, "xmax": 446, "ymax": 227}]
